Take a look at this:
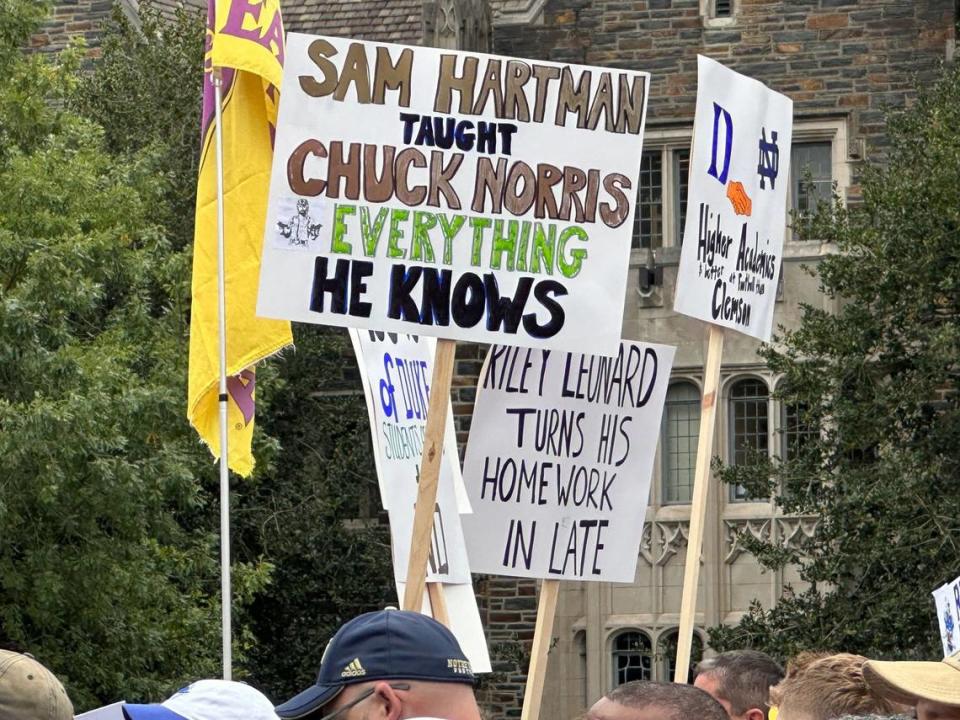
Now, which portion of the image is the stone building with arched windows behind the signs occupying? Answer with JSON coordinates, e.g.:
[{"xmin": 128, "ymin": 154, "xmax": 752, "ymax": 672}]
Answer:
[{"xmin": 35, "ymin": 0, "xmax": 960, "ymax": 720}]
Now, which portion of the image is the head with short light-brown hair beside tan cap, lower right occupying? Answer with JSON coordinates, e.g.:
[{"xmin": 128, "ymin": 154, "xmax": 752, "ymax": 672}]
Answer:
[{"xmin": 770, "ymin": 653, "xmax": 901, "ymax": 720}]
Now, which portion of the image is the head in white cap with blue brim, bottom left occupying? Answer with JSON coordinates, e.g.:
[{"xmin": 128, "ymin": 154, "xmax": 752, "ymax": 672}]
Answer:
[{"xmin": 122, "ymin": 680, "xmax": 277, "ymax": 720}]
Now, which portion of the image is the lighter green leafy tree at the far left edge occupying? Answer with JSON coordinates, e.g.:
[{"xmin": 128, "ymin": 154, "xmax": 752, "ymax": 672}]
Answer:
[{"xmin": 0, "ymin": 0, "xmax": 263, "ymax": 710}]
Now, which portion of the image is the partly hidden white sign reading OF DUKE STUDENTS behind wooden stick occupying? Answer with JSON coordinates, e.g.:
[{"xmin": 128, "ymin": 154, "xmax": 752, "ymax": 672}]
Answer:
[{"xmin": 350, "ymin": 330, "xmax": 472, "ymax": 583}]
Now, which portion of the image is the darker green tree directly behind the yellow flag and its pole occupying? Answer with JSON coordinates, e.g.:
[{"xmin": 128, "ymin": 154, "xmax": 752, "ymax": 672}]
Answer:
[{"xmin": 72, "ymin": 2, "xmax": 393, "ymax": 698}]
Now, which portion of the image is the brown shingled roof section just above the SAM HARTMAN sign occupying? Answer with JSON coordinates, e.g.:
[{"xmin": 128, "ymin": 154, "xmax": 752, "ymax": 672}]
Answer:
[{"xmin": 280, "ymin": 0, "xmax": 423, "ymax": 45}]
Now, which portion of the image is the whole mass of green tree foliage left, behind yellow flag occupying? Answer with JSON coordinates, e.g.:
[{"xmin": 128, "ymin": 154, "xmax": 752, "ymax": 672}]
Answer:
[{"xmin": 0, "ymin": 0, "xmax": 393, "ymax": 710}]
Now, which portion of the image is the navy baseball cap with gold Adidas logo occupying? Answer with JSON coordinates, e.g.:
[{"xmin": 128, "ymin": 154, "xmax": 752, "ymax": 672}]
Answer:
[{"xmin": 275, "ymin": 610, "xmax": 473, "ymax": 720}]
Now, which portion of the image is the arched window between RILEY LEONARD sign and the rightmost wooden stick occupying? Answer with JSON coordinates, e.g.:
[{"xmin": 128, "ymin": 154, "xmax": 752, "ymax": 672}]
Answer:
[{"xmin": 660, "ymin": 382, "xmax": 700, "ymax": 503}]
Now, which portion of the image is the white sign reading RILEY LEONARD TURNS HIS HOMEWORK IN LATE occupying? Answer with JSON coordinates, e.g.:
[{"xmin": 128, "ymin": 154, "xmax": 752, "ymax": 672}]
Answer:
[{"xmin": 463, "ymin": 342, "xmax": 675, "ymax": 582}]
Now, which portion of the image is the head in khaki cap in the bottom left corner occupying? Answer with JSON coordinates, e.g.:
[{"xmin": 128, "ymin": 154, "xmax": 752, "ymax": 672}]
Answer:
[{"xmin": 0, "ymin": 650, "xmax": 73, "ymax": 720}]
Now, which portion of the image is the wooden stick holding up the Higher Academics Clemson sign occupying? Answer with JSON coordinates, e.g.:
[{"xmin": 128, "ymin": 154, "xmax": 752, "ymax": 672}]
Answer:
[{"xmin": 673, "ymin": 325, "xmax": 723, "ymax": 683}]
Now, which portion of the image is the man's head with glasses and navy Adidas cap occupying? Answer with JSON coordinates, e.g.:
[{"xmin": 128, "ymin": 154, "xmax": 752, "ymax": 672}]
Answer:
[{"xmin": 276, "ymin": 610, "xmax": 480, "ymax": 720}]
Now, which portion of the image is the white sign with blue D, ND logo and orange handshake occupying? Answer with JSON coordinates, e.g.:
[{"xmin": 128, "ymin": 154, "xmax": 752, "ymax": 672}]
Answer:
[{"xmin": 673, "ymin": 55, "xmax": 793, "ymax": 340}]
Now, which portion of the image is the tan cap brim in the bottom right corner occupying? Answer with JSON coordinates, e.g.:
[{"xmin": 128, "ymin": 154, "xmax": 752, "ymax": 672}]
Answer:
[{"xmin": 863, "ymin": 660, "xmax": 960, "ymax": 706}]
